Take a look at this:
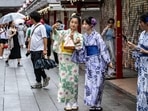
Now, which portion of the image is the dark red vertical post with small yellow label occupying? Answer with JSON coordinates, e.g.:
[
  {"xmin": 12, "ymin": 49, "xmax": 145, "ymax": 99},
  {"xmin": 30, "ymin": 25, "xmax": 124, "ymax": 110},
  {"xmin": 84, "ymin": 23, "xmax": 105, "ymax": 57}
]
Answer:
[{"xmin": 116, "ymin": 0, "xmax": 123, "ymax": 79}]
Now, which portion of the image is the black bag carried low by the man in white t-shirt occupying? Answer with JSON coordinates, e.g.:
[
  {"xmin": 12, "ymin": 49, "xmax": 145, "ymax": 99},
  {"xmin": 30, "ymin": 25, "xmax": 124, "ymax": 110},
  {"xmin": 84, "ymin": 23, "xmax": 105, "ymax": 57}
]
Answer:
[{"xmin": 35, "ymin": 57, "xmax": 57, "ymax": 70}]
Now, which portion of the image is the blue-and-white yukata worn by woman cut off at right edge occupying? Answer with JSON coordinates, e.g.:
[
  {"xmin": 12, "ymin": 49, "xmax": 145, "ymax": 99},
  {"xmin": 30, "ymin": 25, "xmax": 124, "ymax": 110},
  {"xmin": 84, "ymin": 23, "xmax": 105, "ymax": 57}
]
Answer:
[{"xmin": 133, "ymin": 31, "xmax": 148, "ymax": 111}]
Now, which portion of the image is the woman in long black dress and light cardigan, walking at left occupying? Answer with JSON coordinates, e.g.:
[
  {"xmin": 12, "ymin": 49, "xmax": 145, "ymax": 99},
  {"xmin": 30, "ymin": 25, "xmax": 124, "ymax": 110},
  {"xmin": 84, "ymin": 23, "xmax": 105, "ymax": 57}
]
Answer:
[{"xmin": 6, "ymin": 22, "xmax": 22, "ymax": 67}]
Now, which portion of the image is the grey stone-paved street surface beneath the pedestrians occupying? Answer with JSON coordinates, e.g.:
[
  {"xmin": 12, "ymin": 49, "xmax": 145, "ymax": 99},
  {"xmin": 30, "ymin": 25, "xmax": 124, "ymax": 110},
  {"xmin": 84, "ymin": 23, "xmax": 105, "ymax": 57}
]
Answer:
[{"xmin": 0, "ymin": 49, "xmax": 136, "ymax": 111}]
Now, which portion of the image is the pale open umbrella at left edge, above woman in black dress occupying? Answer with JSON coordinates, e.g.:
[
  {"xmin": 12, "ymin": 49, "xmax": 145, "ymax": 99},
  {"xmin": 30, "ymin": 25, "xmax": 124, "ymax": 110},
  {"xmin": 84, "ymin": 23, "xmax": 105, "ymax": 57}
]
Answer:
[{"xmin": 0, "ymin": 12, "xmax": 26, "ymax": 24}]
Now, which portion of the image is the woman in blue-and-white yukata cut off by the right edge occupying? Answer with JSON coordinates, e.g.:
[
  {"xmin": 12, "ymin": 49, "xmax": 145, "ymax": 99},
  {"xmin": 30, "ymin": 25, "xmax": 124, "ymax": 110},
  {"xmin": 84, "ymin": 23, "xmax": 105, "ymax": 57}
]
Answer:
[{"xmin": 128, "ymin": 13, "xmax": 148, "ymax": 111}]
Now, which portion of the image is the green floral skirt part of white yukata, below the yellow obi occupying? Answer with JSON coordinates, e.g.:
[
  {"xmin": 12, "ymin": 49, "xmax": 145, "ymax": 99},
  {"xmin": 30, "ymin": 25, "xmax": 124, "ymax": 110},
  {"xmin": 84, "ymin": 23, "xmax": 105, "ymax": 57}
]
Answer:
[{"xmin": 58, "ymin": 54, "xmax": 79, "ymax": 102}]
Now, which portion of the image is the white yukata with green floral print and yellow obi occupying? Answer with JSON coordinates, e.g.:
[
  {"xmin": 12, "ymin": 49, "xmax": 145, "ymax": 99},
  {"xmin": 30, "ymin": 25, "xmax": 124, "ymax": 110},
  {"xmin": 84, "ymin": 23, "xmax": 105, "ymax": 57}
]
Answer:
[{"xmin": 52, "ymin": 29, "xmax": 83, "ymax": 103}]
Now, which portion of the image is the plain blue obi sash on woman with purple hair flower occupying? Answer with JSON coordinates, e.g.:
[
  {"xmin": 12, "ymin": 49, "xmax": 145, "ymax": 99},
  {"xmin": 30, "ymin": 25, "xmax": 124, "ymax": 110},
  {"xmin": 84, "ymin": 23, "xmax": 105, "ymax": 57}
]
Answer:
[{"xmin": 85, "ymin": 45, "xmax": 99, "ymax": 56}]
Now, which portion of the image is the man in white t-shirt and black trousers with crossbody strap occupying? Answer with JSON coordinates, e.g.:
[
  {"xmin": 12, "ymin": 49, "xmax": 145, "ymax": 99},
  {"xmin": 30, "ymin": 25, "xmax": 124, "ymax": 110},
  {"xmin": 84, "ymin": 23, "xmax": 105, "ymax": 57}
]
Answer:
[{"xmin": 27, "ymin": 12, "xmax": 50, "ymax": 88}]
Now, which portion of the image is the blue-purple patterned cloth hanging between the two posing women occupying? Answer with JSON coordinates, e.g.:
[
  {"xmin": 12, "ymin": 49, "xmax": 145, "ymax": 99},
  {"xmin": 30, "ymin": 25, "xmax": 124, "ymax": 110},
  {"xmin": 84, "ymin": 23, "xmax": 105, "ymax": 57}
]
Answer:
[{"xmin": 71, "ymin": 48, "xmax": 86, "ymax": 64}]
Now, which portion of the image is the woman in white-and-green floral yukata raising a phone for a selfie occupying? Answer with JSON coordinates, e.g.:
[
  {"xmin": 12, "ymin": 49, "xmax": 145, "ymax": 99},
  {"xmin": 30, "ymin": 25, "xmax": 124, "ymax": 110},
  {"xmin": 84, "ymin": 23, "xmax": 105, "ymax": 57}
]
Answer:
[{"xmin": 52, "ymin": 15, "xmax": 83, "ymax": 111}]
